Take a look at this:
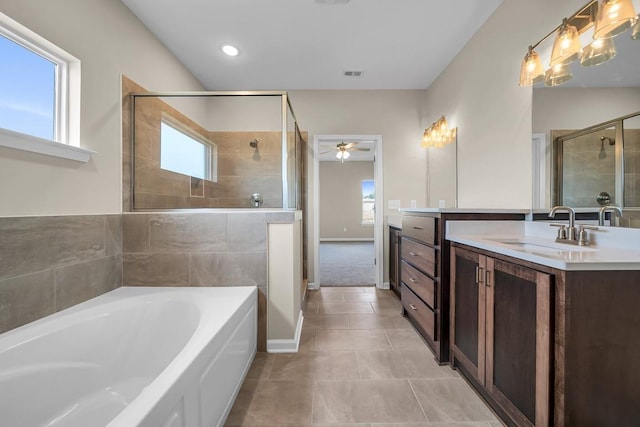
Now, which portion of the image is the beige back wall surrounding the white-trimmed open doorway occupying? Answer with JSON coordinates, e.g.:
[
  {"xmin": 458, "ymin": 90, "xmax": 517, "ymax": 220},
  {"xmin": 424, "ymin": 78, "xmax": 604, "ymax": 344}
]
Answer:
[{"xmin": 289, "ymin": 90, "xmax": 426, "ymax": 282}]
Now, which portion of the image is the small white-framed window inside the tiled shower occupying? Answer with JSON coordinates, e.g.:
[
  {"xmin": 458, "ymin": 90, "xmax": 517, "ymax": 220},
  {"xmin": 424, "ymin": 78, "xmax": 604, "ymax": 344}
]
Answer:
[{"xmin": 160, "ymin": 117, "xmax": 218, "ymax": 182}]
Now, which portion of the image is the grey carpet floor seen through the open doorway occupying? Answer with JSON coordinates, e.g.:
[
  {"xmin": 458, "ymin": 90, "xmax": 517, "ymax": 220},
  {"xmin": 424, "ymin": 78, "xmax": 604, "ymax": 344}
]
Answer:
[{"xmin": 319, "ymin": 242, "xmax": 375, "ymax": 286}]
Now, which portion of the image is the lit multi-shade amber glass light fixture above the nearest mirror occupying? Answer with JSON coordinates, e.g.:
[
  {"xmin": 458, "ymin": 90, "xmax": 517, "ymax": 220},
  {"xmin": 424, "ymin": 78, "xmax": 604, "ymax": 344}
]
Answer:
[{"xmin": 519, "ymin": 0, "xmax": 640, "ymax": 86}]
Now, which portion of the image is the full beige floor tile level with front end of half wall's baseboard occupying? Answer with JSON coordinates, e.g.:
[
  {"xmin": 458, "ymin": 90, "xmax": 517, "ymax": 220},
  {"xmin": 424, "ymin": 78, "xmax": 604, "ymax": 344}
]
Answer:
[{"xmin": 315, "ymin": 329, "xmax": 391, "ymax": 351}]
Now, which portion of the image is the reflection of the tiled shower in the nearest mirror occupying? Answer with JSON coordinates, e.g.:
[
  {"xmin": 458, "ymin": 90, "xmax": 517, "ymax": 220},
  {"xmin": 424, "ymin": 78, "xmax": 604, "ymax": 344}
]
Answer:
[{"xmin": 551, "ymin": 112, "xmax": 640, "ymax": 208}]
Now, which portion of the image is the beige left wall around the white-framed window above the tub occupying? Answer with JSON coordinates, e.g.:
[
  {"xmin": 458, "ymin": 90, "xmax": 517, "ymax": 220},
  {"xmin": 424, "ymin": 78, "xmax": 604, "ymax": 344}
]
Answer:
[{"xmin": 0, "ymin": 0, "xmax": 202, "ymax": 216}]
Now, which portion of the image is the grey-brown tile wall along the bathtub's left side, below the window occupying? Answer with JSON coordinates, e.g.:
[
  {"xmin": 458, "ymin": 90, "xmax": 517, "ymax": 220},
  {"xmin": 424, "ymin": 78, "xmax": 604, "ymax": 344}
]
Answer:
[{"xmin": 0, "ymin": 215, "xmax": 122, "ymax": 333}]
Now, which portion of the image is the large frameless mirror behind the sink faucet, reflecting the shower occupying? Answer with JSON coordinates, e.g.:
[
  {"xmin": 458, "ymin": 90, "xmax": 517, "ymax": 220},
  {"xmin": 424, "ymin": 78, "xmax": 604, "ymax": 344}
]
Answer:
[{"xmin": 532, "ymin": 20, "xmax": 640, "ymax": 224}]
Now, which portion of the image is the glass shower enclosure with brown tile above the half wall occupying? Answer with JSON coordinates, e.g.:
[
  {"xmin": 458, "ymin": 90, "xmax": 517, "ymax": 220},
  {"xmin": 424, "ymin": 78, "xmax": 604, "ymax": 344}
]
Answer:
[{"xmin": 124, "ymin": 88, "xmax": 306, "ymax": 211}]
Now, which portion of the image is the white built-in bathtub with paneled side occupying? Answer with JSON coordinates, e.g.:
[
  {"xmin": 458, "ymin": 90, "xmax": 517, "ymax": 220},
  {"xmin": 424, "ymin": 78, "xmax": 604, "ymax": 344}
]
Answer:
[{"xmin": 0, "ymin": 287, "xmax": 257, "ymax": 427}]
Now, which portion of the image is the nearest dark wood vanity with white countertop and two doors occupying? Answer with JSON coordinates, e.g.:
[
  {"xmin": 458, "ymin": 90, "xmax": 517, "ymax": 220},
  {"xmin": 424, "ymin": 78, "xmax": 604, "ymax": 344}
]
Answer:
[{"xmin": 446, "ymin": 221, "xmax": 640, "ymax": 426}]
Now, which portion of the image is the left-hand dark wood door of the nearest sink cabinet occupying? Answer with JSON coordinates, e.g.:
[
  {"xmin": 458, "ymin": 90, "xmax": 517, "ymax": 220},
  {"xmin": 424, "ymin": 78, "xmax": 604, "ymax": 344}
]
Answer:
[{"xmin": 450, "ymin": 247, "xmax": 486, "ymax": 384}]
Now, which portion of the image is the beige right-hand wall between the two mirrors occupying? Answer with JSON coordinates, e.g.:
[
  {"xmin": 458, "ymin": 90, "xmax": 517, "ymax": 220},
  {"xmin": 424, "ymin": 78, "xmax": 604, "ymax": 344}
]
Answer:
[{"xmin": 422, "ymin": 0, "xmax": 584, "ymax": 208}]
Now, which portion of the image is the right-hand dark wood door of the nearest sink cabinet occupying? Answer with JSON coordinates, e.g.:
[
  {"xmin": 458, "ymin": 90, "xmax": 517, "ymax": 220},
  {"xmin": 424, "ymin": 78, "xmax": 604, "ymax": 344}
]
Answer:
[{"xmin": 485, "ymin": 258, "xmax": 551, "ymax": 426}]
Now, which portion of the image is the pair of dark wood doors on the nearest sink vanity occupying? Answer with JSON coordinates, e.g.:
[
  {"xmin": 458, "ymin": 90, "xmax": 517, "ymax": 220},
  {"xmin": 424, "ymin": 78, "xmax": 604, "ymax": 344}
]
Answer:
[{"xmin": 451, "ymin": 246, "xmax": 552, "ymax": 426}]
